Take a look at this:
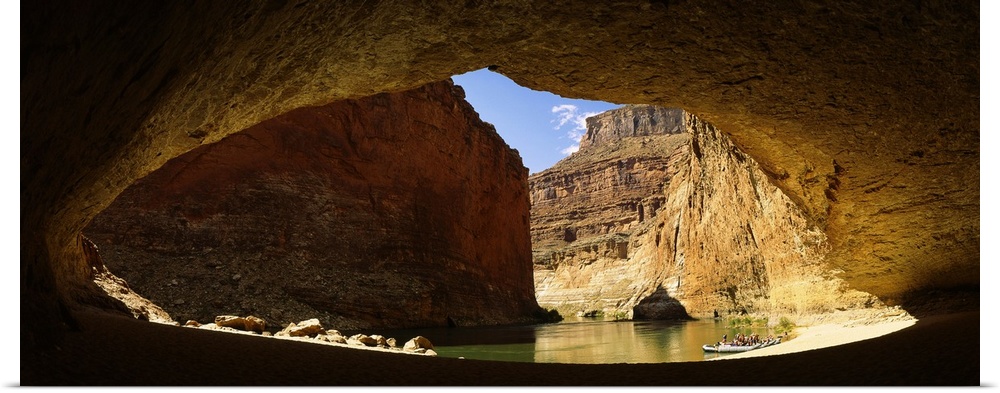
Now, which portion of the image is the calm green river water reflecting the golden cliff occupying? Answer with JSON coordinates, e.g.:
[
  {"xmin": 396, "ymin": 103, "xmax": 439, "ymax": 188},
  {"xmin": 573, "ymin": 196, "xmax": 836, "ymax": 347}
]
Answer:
[{"xmin": 366, "ymin": 318, "xmax": 773, "ymax": 364}]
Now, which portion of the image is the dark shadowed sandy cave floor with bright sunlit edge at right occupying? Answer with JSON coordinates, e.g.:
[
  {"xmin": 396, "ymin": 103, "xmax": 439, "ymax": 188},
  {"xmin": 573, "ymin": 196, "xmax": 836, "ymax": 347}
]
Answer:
[{"xmin": 20, "ymin": 311, "xmax": 980, "ymax": 386}]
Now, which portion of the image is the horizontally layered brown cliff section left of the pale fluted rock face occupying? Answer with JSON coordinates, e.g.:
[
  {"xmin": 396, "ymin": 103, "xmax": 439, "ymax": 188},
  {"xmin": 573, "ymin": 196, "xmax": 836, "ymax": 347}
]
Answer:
[{"xmin": 529, "ymin": 105, "xmax": 690, "ymax": 315}]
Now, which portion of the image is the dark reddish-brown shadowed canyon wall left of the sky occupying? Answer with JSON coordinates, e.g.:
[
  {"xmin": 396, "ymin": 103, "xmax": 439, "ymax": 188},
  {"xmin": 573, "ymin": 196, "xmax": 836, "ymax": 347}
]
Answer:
[{"xmin": 84, "ymin": 81, "xmax": 538, "ymax": 329}]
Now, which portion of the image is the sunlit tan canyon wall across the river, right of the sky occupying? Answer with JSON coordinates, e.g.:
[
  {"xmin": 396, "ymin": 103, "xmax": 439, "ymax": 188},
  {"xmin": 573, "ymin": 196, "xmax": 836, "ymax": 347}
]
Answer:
[{"xmin": 529, "ymin": 105, "xmax": 881, "ymax": 319}]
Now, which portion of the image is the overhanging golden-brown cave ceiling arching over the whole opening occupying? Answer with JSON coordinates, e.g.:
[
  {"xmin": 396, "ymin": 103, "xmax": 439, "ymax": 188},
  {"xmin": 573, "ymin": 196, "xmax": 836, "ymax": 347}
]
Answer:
[{"xmin": 20, "ymin": 1, "xmax": 979, "ymax": 336}]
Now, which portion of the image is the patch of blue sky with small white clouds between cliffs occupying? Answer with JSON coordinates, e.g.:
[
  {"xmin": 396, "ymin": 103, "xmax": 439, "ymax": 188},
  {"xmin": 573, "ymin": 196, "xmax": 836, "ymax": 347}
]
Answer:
[{"xmin": 452, "ymin": 69, "xmax": 621, "ymax": 173}]
